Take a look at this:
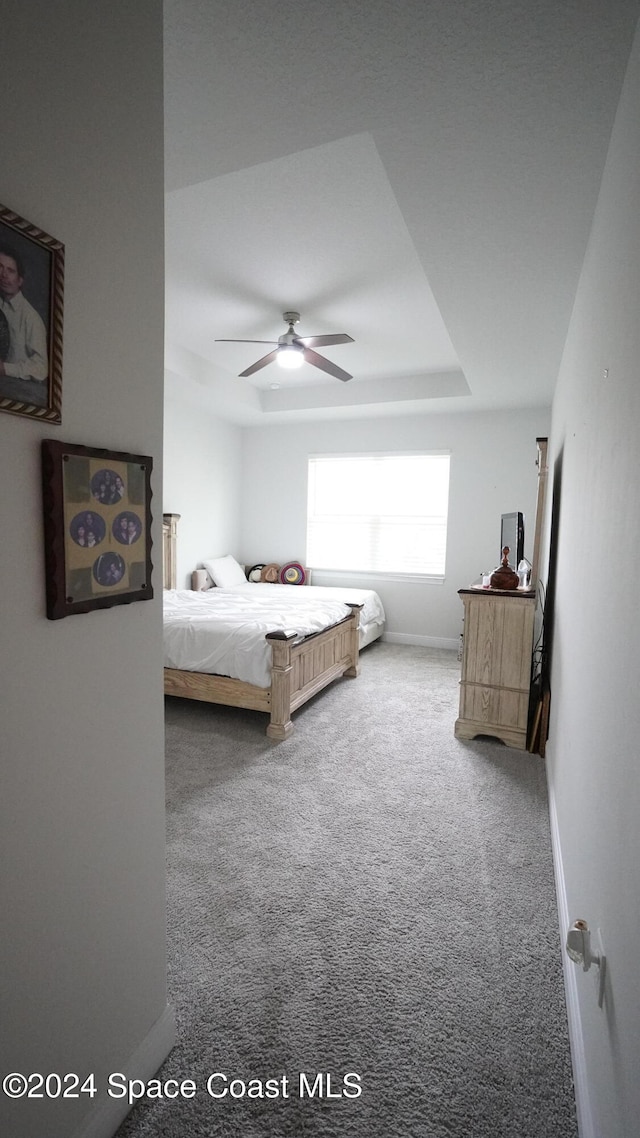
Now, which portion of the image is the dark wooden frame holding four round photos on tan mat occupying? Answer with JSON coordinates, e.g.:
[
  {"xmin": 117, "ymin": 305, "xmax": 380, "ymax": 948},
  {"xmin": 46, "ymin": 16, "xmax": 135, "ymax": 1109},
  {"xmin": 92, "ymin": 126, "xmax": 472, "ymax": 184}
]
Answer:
[{"xmin": 42, "ymin": 438, "xmax": 154, "ymax": 620}]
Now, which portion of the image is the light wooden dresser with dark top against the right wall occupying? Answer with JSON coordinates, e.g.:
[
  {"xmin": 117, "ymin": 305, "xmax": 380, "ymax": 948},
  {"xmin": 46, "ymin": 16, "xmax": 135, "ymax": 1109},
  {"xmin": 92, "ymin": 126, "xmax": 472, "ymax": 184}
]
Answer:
[{"xmin": 456, "ymin": 588, "xmax": 535, "ymax": 750}]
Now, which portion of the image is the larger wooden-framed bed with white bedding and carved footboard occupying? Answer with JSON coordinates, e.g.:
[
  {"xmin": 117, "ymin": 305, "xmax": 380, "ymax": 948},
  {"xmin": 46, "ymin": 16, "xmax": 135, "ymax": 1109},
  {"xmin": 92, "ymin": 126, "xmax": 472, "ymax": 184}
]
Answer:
[{"xmin": 163, "ymin": 514, "xmax": 384, "ymax": 740}]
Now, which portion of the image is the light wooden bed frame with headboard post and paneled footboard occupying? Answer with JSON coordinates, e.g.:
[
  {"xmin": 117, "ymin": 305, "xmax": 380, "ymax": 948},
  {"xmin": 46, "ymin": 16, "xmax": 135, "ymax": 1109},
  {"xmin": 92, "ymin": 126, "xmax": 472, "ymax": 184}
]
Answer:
[{"xmin": 163, "ymin": 513, "xmax": 362, "ymax": 740}]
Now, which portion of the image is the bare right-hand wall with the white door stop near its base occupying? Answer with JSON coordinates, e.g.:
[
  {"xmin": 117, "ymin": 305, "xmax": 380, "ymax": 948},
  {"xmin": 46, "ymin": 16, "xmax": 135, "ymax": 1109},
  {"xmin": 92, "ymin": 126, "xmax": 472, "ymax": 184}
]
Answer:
[{"xmin": 547, "ymin": 17, "xmax": 640, "ymax": 1138}]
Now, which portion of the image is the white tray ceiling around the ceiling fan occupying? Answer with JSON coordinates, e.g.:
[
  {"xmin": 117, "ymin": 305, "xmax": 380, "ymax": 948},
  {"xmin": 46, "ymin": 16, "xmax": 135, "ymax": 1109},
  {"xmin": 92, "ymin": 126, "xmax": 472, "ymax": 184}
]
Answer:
[{"xmin": 164, "ymin": 0, "xmax": 640, "ymax": 423}]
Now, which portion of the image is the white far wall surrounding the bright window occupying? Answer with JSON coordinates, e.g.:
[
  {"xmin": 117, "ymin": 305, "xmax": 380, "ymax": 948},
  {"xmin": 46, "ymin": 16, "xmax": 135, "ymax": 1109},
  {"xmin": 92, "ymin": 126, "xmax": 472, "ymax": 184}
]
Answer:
[{"xmin": 239, "ymin": 409, "xmax": 549, "ymax": 645}]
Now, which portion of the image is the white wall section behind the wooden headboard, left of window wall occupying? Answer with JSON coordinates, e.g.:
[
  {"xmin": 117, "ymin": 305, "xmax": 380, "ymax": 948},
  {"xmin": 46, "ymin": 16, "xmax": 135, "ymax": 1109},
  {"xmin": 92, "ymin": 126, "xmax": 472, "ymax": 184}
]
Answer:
[{"xmin": 164, "ymin": 372, "xmax": 243, "ymax": 588}]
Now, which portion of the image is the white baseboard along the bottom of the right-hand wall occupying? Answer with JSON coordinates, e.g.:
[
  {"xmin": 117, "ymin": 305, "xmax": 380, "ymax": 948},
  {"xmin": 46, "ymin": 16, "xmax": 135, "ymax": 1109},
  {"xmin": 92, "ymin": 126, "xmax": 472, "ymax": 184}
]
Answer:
[{"xmin": 547, "ymin": 777, "xmax": 598, "ymax": 1138}]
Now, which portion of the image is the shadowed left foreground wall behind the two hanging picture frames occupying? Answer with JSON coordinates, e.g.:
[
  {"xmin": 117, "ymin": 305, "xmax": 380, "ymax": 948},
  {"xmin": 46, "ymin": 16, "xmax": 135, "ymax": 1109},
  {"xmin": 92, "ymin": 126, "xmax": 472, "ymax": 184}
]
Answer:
[{"xmin": 0, "ymin": 0, "xmax": 173, "ymax": 1138}]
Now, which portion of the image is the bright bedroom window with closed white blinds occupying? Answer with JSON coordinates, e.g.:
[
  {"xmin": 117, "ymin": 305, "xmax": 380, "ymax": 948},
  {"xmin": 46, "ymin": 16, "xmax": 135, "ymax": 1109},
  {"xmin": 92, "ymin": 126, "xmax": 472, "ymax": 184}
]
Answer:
[{"xmin": 306, "ymin": 453, "xmax": 450, "ymax": 577}]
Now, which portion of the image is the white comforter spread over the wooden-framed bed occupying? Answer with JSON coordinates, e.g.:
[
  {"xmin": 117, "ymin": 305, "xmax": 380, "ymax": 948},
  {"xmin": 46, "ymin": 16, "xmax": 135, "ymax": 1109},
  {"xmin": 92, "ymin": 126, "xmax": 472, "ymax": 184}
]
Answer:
[{"xmin": 164, "ymin": 582, "xmax": 384, "ymax": 687}]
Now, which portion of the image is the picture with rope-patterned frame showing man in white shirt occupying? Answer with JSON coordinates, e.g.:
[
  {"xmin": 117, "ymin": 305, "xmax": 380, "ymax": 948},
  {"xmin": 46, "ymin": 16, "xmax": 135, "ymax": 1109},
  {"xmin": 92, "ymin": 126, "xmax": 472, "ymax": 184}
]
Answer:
[{"xmin": 0, "ymin": 206, "xmax": 65, "ymax": 423}]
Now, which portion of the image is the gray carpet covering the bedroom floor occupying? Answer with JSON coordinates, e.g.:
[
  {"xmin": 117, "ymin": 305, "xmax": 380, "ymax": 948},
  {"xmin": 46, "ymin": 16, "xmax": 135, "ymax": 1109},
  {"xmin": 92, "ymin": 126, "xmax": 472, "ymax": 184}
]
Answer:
[{"xmin": 118, "ymin": 643, "xmax": 577, "ymax": 1138}]
